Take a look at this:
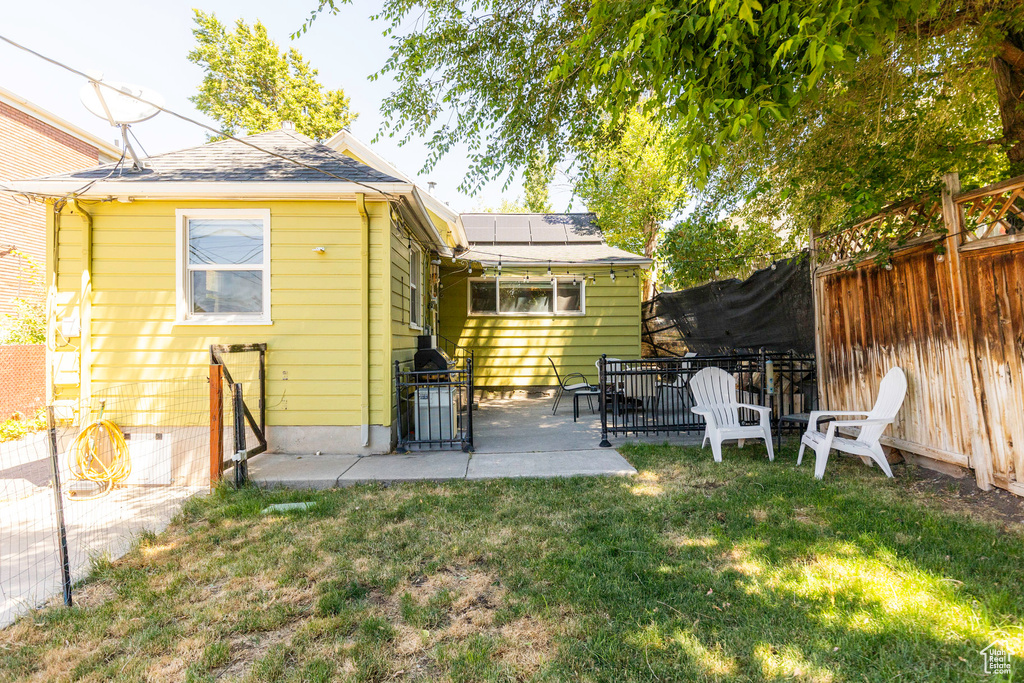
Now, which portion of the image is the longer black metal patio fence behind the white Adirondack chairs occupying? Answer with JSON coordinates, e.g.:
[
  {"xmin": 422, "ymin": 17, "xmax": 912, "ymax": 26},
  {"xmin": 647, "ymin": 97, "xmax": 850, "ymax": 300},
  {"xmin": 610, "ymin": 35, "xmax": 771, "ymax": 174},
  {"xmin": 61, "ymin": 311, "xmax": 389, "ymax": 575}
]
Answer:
[{"xmin": 598, "ymin": 352, "xmax": 817, "ymax": 446}]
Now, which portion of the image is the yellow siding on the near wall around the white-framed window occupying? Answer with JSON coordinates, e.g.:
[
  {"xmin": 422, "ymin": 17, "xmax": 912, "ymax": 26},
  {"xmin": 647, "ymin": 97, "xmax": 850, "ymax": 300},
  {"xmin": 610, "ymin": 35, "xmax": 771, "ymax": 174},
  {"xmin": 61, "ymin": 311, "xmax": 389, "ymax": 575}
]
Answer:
[{"xmin": 56, "ymin": 201, "xmax": 391, "ymax": 426}]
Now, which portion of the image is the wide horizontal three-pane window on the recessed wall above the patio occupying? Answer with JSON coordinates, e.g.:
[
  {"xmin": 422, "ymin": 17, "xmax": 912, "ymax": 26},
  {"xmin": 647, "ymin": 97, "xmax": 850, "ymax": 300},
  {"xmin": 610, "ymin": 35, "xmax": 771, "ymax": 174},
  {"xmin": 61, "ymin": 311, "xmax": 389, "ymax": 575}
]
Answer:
[{"xmin": 469, "ymin": 278, "xmax": 585, "ymax": 315}]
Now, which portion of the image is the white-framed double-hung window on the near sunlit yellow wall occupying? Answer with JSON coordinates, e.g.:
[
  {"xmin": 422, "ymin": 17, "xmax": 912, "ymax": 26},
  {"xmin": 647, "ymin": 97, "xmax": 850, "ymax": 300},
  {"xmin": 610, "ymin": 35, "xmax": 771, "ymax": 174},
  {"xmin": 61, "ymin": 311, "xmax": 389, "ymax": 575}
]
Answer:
[{"xmin": 176, "ymin": 209, "xmax": 270, "ymax": 325}]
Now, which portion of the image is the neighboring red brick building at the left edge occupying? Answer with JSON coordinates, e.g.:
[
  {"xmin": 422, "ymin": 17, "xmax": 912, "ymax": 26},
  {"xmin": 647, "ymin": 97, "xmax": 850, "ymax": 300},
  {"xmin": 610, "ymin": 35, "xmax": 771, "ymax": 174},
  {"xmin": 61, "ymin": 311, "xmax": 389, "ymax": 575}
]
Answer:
[{"xmin": 0, "ymin": 88, "xmax": 121, "ymax": 315}]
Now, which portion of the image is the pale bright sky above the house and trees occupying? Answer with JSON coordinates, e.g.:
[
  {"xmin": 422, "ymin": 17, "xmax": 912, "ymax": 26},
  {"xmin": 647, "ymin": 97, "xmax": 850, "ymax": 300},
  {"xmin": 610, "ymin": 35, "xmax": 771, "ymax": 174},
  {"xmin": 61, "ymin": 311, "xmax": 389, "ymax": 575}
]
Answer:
[{"xmin": 0, "ymin": 0, "xmax": 582, "ymax": 211}]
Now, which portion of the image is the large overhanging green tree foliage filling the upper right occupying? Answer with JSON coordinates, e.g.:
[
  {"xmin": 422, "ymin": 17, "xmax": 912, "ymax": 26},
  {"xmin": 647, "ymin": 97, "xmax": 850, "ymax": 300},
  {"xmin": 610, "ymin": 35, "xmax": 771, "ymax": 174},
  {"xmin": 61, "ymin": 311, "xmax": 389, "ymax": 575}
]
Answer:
[{"xmin": 303, "ymin": 0, "xmax": 1024, "ymax": 259}]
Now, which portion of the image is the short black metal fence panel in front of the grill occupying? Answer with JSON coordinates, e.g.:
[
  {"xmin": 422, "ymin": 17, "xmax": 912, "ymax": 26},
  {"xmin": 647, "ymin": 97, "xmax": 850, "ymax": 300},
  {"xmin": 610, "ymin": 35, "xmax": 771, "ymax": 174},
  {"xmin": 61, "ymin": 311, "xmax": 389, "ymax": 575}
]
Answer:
[{"xmin": 394, "ymin": 355, "xmax": 473, "ymax": 453}]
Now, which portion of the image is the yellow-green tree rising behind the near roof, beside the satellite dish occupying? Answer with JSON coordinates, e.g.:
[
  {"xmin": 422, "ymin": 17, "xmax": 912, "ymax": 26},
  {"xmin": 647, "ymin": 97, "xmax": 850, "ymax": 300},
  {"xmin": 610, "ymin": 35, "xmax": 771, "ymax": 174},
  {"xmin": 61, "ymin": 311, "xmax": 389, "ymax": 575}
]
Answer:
[{"xmin": 188, "ymin": 9, "xmax": 356, "ymax": 140}]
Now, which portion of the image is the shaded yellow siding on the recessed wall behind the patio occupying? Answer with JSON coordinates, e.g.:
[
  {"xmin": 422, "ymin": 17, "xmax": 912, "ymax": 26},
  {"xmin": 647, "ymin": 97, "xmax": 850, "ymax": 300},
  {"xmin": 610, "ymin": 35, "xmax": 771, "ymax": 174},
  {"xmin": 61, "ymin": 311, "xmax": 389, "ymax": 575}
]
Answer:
[{"xmin": 440, "ymin": 268, "xmax": 640, "ymax": 387}]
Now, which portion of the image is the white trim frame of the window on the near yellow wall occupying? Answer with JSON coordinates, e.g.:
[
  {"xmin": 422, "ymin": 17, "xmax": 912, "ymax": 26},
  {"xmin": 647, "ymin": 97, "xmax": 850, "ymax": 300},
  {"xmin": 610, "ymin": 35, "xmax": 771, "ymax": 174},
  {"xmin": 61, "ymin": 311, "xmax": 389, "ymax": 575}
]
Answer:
[{"xmin": 174, "ymin": 209, "xmax": 273, "ymax": 326}]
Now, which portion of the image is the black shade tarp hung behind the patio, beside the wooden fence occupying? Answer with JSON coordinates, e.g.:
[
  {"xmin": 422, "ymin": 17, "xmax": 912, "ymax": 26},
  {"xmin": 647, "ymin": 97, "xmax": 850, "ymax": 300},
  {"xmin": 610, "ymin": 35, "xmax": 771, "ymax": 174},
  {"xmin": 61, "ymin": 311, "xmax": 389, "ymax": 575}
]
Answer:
[{"xmin": 642, "ymin": 253, "xmax": 814, "ymax": 355}]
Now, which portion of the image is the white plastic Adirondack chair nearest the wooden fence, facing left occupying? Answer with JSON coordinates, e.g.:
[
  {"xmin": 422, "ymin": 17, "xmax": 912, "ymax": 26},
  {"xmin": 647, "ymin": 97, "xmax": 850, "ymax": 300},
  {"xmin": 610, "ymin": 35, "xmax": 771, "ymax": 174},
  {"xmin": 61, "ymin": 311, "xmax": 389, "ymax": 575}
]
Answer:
[{"xmin": 797, "ymin": 368, "xmax": 906, "ymax": 479}]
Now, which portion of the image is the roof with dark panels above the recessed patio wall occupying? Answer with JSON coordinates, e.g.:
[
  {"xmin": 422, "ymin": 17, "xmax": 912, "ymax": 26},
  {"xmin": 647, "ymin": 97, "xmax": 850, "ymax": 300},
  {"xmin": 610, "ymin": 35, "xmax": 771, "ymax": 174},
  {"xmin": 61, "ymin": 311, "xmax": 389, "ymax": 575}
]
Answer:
[{"xmin": 459, "ymin": 213, "xmax": 651, "ymax": 266}]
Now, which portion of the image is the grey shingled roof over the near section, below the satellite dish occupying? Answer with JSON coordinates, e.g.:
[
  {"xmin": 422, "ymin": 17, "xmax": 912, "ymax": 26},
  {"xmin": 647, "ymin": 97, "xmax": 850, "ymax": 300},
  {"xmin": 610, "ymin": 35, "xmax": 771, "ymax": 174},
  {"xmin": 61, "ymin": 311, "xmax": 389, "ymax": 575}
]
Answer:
[{"xmin": 25, "ymin": 130, "xmax": 402, "ymax": 183}]
